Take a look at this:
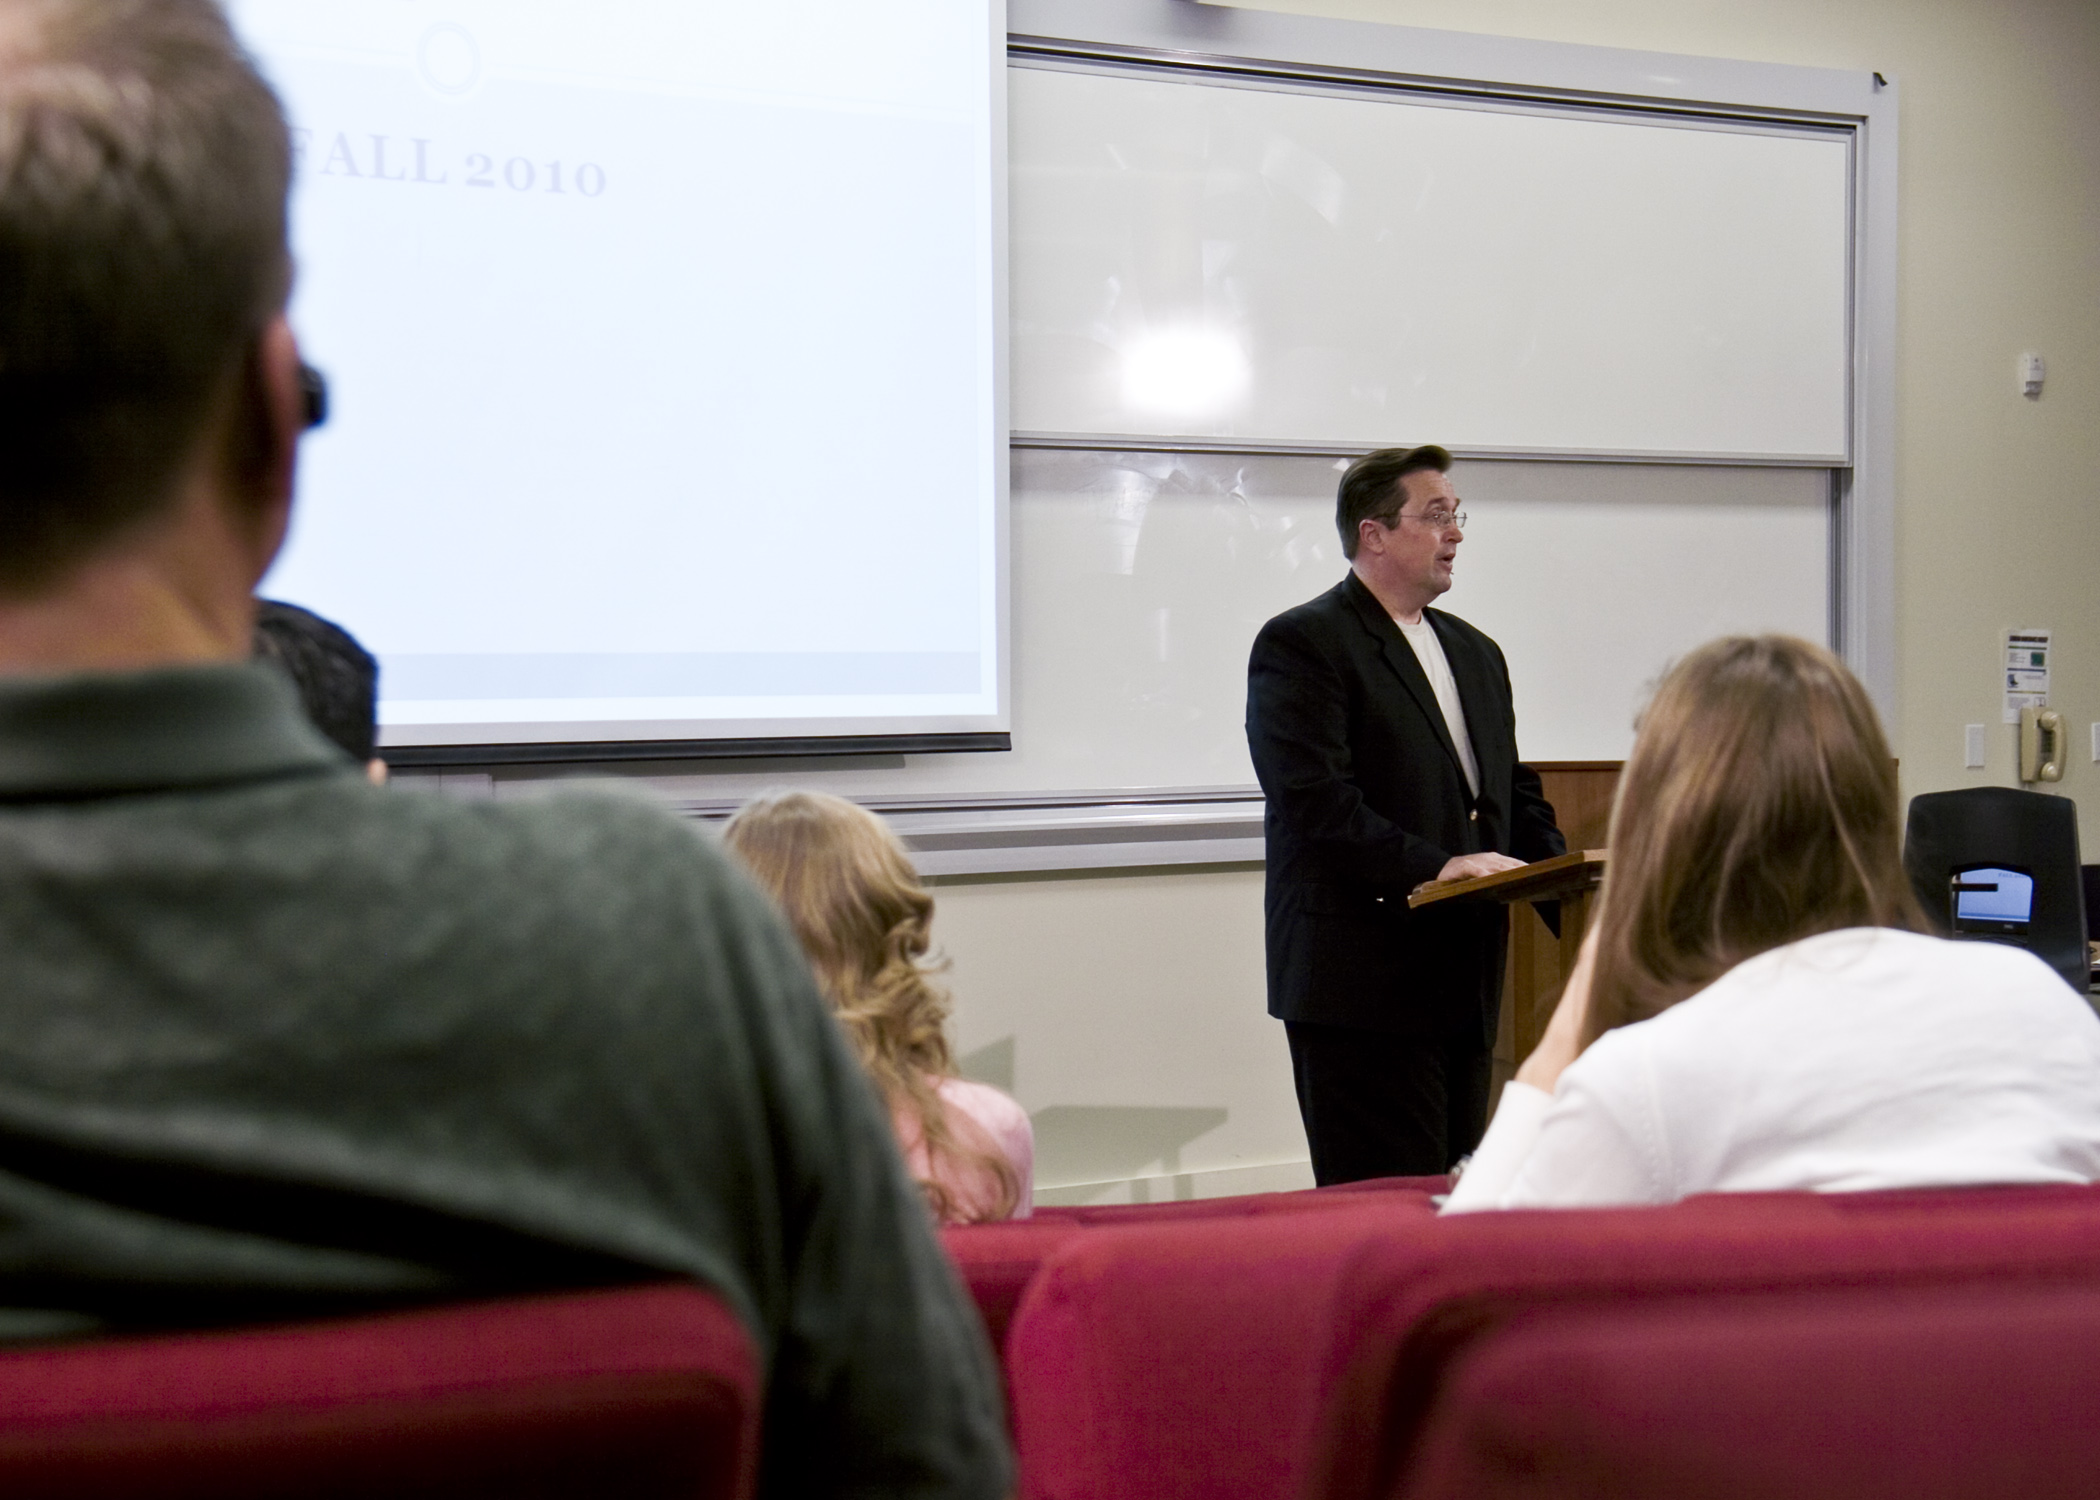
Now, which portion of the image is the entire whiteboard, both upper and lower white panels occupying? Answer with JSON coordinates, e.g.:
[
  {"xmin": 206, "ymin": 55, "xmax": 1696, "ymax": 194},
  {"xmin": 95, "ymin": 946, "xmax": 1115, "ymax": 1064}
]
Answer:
[{"xmin": 443, "ymin": 32, "xmax": 1850, "ymax": 803}]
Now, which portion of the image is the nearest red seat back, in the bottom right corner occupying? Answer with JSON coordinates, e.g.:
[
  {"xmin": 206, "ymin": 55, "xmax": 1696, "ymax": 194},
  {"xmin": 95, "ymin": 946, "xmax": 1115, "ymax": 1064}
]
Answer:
[{"xmin": 1403, "ymin": 1284, "xmax": 2100, "ymax": 1500}]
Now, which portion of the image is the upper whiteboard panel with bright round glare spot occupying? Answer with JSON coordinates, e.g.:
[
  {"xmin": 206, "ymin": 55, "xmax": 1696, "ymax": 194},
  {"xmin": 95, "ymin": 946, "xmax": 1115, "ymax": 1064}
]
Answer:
[{"xmin": 1008, "ymin": 65, "xmax": 1852, "ymax": 462}]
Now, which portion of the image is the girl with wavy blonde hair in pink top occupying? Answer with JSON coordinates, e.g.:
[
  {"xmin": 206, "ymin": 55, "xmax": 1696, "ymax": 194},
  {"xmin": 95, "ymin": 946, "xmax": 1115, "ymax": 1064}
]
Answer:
[{"xmin": 722, "ymin": 792, "xmax": 1035, "ymax": 1225}]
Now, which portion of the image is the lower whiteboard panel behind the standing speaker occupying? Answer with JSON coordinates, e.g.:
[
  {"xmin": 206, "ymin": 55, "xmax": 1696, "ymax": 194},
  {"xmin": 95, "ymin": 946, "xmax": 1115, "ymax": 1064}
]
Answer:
[{"xmin": 604, "ymin": 452, "xmax": 1829, "ymax": 798}]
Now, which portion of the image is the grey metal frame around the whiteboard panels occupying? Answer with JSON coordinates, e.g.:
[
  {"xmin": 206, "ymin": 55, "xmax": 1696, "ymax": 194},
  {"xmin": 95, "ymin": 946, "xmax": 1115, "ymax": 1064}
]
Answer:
[{"xmin": 1006, "ymin": 0, "xmax": 1896, "ymax": 723}]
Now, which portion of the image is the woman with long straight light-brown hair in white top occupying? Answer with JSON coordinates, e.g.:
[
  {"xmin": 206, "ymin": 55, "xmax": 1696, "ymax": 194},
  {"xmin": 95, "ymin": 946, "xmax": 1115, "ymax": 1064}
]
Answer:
[{"xmin": 1447, "ymin": 637, "xmax": 2100, "ymax": 1212}]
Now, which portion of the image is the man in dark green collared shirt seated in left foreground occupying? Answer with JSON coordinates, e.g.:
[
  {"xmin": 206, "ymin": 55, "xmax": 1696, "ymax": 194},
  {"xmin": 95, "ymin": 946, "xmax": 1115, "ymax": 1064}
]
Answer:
[{"xmin": 0, "ymin": 0, "xmax": 1010, "ymax": 1500}]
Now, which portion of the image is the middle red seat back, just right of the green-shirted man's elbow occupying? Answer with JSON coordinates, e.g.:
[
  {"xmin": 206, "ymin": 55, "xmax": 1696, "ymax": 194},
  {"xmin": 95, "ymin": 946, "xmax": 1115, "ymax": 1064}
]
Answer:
[{"xmin": 1006, "ymin": 1193, "xmax": 1436, "ymax": 1500}]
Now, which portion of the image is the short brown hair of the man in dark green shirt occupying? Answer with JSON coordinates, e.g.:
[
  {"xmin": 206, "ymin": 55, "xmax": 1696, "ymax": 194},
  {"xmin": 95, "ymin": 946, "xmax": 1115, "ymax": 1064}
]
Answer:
[{"xmin": 0, "ymin": 0, "xmax": 292, "ymax": 590}]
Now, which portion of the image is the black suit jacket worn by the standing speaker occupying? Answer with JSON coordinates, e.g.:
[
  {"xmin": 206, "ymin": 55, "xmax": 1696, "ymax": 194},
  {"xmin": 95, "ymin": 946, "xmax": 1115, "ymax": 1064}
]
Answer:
[{"xmin": 1247, "ymin": 574, "xmax": 1567, "ymax": 1044}]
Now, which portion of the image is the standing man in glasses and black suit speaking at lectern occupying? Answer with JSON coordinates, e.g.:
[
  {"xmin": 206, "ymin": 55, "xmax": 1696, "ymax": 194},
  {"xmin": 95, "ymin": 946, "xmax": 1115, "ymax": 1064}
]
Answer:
[{"xmin": 1247, "ymin": 447, "xmax": 1567, "ymax": 1183}]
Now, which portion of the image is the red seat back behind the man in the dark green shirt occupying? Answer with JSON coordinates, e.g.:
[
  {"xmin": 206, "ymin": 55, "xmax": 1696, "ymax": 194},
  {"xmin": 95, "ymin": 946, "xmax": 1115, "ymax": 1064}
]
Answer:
[{"xmin": 0, "ymin": 1284, "xmax": 760, "ymax": 1500}]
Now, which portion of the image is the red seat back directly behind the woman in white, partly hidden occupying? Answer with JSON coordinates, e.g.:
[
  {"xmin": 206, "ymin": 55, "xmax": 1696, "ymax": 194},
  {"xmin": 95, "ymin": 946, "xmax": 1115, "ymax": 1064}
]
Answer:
[{"xmin": 1306, "ymin": 1187, "xmax": 2100, "ymax": 1500}]
